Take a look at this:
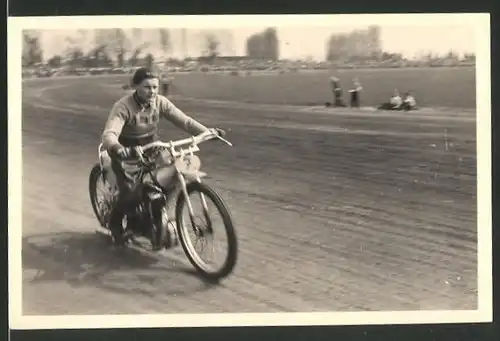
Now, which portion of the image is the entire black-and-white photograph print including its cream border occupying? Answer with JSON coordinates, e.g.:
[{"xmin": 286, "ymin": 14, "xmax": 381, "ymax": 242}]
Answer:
[{"xmin": 8, "ymin": 14, "xmax": 492, "ymax": 329}]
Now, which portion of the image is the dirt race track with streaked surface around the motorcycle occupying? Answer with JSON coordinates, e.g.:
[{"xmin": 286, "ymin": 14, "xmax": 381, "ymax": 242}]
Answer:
[{"xmin": 23, "ymin": 79, "xmax": 477, "ymax": 315}]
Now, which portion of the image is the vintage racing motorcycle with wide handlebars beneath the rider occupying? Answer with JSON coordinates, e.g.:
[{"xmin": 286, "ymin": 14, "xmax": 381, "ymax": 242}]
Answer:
[{"xmin": 89, "ymin": 129, "xmax": 238, "ymax": 281}]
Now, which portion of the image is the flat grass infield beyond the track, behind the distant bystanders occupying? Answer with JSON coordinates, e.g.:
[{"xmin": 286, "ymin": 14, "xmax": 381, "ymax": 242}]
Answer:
[{"xmin": 169, "ymin": 68, "xmax": 476, "ymax": 108}]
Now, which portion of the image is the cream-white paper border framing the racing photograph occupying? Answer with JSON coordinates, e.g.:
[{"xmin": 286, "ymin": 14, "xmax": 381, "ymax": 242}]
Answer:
[{"xmin": 7, "ymin": 13, "xmax": 493, "ymax": 329}]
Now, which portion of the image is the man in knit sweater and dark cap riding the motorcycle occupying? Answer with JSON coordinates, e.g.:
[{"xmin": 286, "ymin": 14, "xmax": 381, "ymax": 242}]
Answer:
[{"xmin": 102, "ymin": 68, "xmax": 224, "ymax": 245}]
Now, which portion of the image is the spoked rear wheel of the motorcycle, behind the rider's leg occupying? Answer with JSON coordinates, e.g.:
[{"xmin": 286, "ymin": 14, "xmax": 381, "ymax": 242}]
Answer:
[{"xmin": 89, "ymin": 164, "xmax": 113, "ymax": 227}]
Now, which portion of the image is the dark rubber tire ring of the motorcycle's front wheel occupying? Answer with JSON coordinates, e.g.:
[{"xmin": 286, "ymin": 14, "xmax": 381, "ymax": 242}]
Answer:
[{"xmin": 175, "ymin": 182, "xmax": 238, "ymax": 282}]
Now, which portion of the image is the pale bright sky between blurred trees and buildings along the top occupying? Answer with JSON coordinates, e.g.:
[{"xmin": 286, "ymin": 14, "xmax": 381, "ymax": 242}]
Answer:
[{"xmin": 36, "ymin": 24, "xmax": 476, "ymax": 61}]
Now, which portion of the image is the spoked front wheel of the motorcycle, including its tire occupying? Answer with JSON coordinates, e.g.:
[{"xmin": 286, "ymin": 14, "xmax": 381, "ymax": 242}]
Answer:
[{"xmin": 175, "ymin": 182, "xmax": 238, "ymax": 281}]
